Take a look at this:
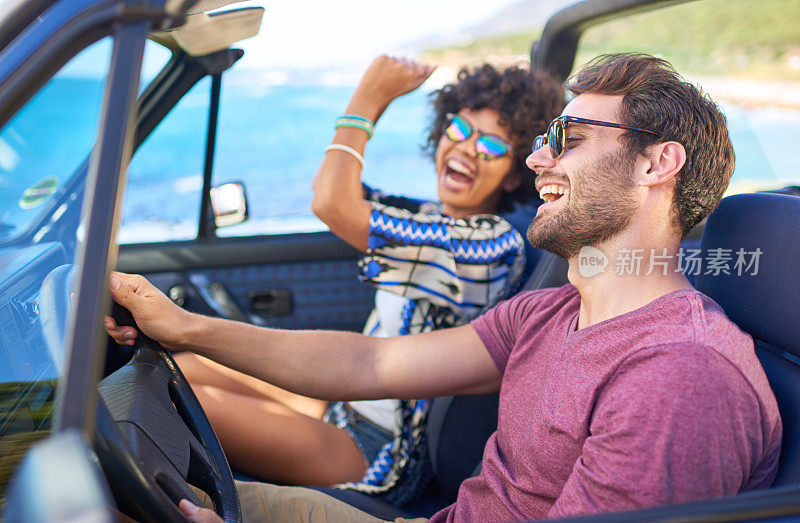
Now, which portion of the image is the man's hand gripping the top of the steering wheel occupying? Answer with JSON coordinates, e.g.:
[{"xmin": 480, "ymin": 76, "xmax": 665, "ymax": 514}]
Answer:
[{"xmin": 103, "ymin": 272, "xmax": 191, "ymax": 350}]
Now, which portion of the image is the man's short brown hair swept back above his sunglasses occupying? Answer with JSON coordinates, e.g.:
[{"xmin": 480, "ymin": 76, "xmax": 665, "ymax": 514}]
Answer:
[{"xmin": 565, "ymin": 54, "xmax": 734, "ymax": 235}]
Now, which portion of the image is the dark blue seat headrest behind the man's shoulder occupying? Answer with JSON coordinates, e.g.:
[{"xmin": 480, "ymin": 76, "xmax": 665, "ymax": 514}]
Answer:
[{"xmin": 695, "ymin": 193, "xmax": 800, "ymax": 357}]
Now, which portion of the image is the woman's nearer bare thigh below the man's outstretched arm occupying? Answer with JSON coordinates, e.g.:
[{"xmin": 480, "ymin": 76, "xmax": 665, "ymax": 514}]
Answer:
[{"xmin": 194, "ymin": 385, "xmax": 366, "ymax": 485}]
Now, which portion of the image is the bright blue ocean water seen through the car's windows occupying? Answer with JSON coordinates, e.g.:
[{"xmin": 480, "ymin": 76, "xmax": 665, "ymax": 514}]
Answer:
[{"xmin": 0, "ymin": 77, "xmax": 800, "ymax": 243}]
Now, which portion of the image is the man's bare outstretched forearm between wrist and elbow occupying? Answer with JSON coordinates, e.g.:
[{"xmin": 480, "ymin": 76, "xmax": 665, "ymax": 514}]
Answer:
[{"xmin": 180, "ymin": 315, "xmax": 385, "ymax": 400}]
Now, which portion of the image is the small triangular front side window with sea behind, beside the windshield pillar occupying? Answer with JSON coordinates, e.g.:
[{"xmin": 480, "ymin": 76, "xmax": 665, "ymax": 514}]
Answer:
[{"xmin": 117, "ymin": 77, "xmax": 211, "ymax": 244}]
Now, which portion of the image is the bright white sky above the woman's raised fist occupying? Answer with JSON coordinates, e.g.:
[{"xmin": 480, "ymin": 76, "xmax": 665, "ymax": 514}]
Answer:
[{"xmin": 222, "ymin": 0, "xmax": 517, "ymax": 69}]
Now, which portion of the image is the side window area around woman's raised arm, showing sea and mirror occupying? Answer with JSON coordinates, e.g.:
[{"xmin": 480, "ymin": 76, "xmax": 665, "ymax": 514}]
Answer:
[{"xmin": 212, "ymin": 77, "xmax": 436, "ymax": 237}]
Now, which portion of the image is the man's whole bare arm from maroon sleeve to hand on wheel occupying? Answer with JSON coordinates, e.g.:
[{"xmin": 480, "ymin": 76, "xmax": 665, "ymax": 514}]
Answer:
[{"xmin": 104, "ymin": 272, "xmax": 500, "ymax": 400}]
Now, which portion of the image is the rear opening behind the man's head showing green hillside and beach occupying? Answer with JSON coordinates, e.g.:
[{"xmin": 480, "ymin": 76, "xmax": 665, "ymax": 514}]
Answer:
[{"xmin": 576, "ymin": 0, "xmax": 800, "ymax": 194}]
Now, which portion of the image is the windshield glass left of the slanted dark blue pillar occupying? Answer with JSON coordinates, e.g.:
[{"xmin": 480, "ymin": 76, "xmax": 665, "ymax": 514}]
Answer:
[{"xmin": 0, "ymin": 38, "xmax": 112, "ymax": 505}]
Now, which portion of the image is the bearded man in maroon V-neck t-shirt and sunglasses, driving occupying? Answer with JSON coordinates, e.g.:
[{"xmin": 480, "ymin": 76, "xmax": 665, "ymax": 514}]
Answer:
[{"xmin": 106, "ymin": 54, "xmax": 781, "ymax": 521}]
